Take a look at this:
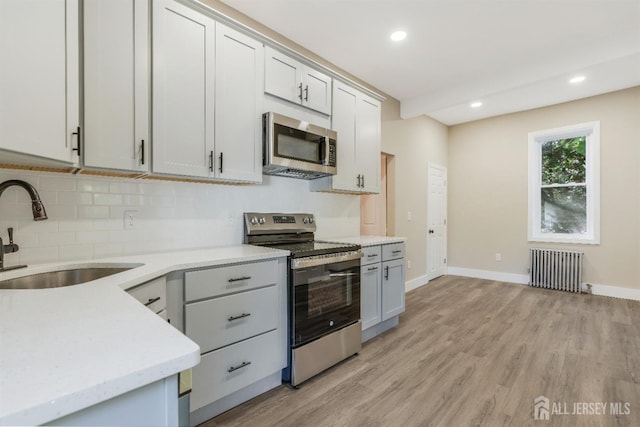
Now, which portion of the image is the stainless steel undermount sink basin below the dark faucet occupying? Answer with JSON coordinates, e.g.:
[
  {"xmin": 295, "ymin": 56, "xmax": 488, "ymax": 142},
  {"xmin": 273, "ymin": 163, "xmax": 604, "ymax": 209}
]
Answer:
[{"xmin": 0, "ymin": 264, "xmax": 142, "ymax": 289}]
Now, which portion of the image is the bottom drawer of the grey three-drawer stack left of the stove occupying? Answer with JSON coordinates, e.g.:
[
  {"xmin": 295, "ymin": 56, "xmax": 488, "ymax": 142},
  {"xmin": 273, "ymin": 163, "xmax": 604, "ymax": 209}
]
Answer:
[{"xmin": 191, "ymin": 331, "xmax": 284, "ymax": 412}]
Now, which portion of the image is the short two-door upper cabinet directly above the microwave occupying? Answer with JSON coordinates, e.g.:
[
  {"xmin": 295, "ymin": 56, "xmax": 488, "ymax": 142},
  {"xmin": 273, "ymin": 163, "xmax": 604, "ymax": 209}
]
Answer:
[{"xmin": 264, "ymin": 46, "xmax": 332, "ymax": 115}]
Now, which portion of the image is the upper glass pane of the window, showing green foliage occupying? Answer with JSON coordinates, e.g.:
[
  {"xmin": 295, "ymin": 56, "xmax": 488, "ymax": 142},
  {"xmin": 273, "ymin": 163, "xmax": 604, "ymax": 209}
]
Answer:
[{"xmin": 542, "ymin": 136, "xmax": 587, "ymax": 185}]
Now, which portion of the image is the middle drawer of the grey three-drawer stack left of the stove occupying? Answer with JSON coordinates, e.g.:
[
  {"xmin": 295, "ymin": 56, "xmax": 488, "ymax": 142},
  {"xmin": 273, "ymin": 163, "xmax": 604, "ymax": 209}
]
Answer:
[{"xmin": 185, "ymin": 286, "xmax": 281, "ymax": 353}]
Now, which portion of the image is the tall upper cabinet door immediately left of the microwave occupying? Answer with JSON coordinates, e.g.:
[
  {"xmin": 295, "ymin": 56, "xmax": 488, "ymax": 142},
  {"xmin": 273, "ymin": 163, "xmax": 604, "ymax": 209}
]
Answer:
[{"xmin": 214, "ymin": 23, "xmax": 264, "ymax": 182}]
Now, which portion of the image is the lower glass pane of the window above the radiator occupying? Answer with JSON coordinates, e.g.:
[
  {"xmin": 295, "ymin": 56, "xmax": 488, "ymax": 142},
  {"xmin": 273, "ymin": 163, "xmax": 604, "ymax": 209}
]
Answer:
[{"xmin": 540, "ymin": 186, "xmax": 587, "ymax": 234}]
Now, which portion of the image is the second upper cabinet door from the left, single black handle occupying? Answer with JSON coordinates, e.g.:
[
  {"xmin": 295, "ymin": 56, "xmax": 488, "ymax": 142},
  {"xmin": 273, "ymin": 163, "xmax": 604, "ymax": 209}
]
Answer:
[{"xmin": 83, "ymin": 0, "xmax": 150, "ymax": 172}]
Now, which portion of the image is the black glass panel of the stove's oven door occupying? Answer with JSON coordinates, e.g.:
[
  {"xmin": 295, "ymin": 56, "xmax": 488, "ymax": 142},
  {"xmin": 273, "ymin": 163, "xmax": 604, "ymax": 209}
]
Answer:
[{"xmin": 290, "ymin": 258, "xmax": 360, "ymax": 348}]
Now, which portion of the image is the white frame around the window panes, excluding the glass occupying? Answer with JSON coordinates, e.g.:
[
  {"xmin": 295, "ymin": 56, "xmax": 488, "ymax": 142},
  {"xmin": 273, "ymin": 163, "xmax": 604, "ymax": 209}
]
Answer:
[{"xmin": 528, "ymin": 121, "xmax": 600, "ymax": 245}]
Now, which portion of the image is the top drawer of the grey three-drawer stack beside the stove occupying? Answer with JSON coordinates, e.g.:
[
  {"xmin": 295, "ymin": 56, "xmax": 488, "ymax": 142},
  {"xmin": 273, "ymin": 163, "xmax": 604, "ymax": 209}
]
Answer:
[{"xmin": 184, "ymin": 260, "xmax": 278, "ymax": 302}]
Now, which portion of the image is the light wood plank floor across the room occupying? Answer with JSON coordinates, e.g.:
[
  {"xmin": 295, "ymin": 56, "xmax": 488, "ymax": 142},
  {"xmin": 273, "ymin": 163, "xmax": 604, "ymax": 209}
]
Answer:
[{"xmin": 202, "ymin": 276, "xmax": 640, "ymax": 427}]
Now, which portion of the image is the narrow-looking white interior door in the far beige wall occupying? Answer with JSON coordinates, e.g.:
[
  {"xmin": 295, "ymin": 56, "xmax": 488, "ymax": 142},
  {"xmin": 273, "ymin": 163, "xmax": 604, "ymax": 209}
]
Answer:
[{"xmin": 427, "ymin": 164, "xmax": 447, "ymax": 280}]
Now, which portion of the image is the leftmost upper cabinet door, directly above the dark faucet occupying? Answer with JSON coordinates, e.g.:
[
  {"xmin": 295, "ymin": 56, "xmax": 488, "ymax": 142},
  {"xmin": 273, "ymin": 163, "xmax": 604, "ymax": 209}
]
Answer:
[{"xmin": 0, "ymin": 0, "xmax": 80, "ymax": 164}]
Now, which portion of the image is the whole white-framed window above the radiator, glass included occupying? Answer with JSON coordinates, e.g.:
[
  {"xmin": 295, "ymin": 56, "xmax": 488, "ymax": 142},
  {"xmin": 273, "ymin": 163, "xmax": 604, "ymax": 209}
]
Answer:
[{"xmin": 529, "ymin": 122, "xmax": 600, "ymax": 244}]
